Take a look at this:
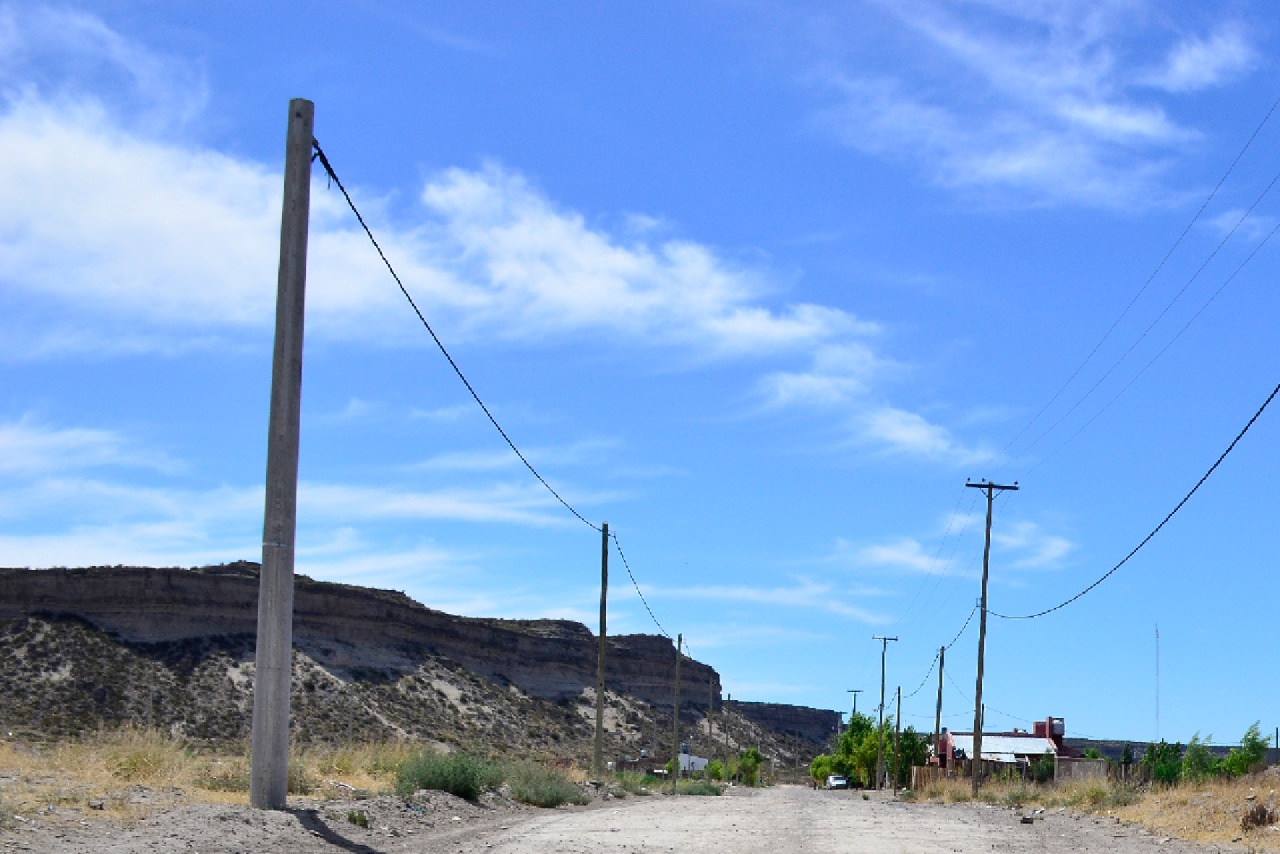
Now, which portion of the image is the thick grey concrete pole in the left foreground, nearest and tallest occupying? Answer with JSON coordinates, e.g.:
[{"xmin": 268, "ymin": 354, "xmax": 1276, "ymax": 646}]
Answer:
[{"xmin": 248, "ymin": 99, "xmax": 315, "ymax": 809}]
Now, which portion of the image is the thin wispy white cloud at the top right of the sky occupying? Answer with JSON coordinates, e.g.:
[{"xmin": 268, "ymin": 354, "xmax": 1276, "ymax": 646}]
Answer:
[{"xmin": 812, "ymin": 0, "xmax": 1254, "ymax": 206}]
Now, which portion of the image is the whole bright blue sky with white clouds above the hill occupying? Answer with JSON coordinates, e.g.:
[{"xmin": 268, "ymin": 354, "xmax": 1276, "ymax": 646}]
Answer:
[{"xmin": 0, "ymin": 0, "xmax": 1280, "ymax": 741}]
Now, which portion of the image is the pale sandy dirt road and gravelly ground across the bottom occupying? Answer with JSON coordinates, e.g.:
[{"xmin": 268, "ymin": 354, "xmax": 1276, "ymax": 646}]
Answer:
[{"xmin": 0, "ymin": 786, "xmax": 1249, "ymax": 854}]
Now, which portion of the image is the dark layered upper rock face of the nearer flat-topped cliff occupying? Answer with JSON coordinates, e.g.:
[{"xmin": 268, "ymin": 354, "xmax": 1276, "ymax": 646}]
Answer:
[{"xmin": 0, "ymin": 562, "xmax": 721, "ymax": 709}]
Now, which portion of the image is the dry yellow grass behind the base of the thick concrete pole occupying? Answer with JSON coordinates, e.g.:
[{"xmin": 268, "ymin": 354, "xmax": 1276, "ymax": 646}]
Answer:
[{"xmin": 0, "ymin": 727, "xmax": 420, "ymax": 821}]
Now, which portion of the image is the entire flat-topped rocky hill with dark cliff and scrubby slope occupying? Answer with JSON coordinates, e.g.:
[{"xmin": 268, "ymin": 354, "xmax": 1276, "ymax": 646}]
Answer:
[{"xmin": 0, "ymin": 563, "xmax": 838, "ymax": 766}]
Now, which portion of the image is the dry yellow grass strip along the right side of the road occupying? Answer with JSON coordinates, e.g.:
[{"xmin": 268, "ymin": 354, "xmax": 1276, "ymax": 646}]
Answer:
[{"xmin": 918, "ymin": 775, "xmax": 1280, "ymax": 851}]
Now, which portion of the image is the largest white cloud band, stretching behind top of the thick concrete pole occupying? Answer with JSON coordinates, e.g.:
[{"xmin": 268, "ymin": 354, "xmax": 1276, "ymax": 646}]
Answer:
[{"xmin": 0, "ymin": 6, "xmax": 1007, "ymax": 466}]
